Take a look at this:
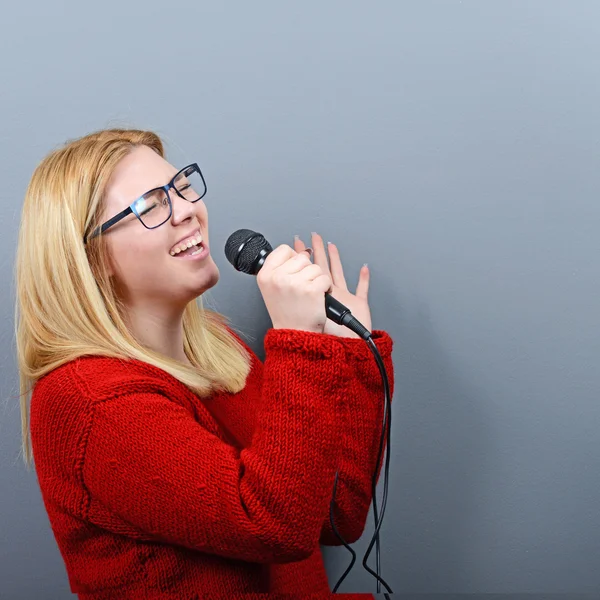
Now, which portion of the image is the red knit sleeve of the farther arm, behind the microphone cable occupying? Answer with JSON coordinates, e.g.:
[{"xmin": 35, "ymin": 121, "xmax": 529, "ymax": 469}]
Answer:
[{"xmin": 320, "ymin": 330, "xmax": 394, "ymax": 546}]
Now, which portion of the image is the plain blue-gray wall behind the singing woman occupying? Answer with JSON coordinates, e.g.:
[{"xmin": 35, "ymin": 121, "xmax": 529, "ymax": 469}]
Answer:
[{"xmin": 0, "ymin": 0, "xmax": 600, "ymax": 599}]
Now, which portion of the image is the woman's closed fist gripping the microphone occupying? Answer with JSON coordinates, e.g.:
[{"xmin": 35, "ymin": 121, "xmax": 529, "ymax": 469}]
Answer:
[{"xmin": 256, "ymin": 244, "xmax": 332, "ymax": 333}]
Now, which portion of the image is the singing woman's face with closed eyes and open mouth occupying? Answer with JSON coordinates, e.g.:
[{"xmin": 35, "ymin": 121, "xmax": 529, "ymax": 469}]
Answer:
[{"xmin": 102, "ymin": 146, "xmax": 219, "ymax": 308}]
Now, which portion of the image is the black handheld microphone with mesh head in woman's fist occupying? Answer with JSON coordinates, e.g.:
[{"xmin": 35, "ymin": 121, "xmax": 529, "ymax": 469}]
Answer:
[{"xmin": 225, "ymin": 229, "xmax": 371, "ymax": 340}]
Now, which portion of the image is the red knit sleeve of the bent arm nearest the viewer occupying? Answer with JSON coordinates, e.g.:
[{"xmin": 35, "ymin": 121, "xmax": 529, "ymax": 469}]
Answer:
[{"xmin": 82, "ymin": 330, "xmax": 349, "ymax": 563}]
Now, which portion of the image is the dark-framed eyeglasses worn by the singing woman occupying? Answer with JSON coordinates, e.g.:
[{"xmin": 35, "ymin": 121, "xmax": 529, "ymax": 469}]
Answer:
[{"xmin": 83, "ymin": 163, "xmax": 206, "ymax": 244}]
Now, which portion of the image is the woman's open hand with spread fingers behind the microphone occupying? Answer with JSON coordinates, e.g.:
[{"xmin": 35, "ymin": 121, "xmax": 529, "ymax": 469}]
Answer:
[{"xmin": 294, "ymin": 233, "xmax": 371, "ymax": 338}]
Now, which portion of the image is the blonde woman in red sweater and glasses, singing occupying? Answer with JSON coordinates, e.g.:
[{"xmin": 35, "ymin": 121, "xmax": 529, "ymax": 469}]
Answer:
[{"xmin": 17, "ymin": 130, "xmax": 393, "ymax": 600}]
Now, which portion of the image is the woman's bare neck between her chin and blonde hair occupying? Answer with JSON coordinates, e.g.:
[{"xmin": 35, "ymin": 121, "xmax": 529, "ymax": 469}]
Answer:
[{"xmin": 127, "ymin": 305, "xmax": 190, "ymax": 364}]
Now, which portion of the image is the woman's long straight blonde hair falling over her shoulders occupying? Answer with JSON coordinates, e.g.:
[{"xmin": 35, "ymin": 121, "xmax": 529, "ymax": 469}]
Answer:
[{"xmin": 16, "ymin": 129, "xmax": 250, "ymax": 466}]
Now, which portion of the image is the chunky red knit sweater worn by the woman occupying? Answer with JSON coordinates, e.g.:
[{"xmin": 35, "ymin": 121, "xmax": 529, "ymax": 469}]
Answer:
[{"xmin": 31, "ymin": 329, "xmax": 394, "ymax": 600}]
